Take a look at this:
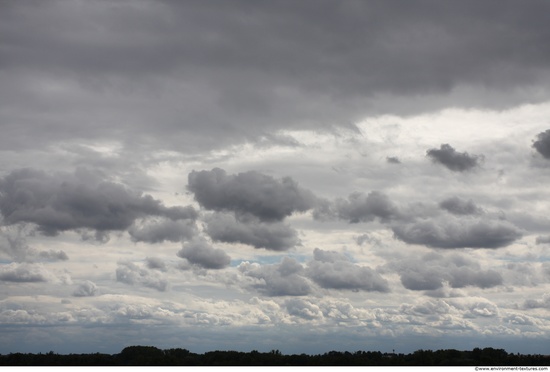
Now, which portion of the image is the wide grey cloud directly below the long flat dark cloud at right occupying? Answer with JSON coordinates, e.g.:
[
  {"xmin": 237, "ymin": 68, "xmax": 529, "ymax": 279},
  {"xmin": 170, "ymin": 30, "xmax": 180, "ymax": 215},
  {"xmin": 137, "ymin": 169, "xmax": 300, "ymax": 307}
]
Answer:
[{"xmin": 396, "ymin": 253, "xmax": 503, "ymax": 291}]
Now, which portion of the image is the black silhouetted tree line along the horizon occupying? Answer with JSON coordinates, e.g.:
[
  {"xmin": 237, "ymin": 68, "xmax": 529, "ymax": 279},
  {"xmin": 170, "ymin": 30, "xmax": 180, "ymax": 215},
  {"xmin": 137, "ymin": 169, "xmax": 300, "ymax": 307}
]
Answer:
[{"xmin": 0, "ymin": 346, "xmax": 550, "ymax": 366}]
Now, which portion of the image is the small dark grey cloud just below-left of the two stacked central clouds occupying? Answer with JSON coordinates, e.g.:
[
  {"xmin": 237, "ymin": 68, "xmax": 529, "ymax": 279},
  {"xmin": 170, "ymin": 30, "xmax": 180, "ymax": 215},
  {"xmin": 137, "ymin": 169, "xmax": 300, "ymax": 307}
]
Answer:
[{"xmin": 178, "ymin": 238, "xmax": 231, "ymax": 269}]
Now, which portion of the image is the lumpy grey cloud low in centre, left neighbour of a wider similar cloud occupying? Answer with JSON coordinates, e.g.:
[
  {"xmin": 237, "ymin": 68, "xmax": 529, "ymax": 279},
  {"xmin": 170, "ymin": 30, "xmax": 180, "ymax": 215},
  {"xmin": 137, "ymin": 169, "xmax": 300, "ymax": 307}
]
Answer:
[{"xmin": 239, "ymin": 257, "xmax": 312, "ymax": 296}]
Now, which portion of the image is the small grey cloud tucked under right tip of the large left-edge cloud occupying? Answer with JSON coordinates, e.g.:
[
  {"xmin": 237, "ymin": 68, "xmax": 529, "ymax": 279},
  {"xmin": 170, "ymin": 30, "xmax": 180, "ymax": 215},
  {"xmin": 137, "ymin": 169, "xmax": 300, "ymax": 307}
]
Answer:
[{"xmin": 128, "ymin": 218, "xmax": 197, "ymax": 243}]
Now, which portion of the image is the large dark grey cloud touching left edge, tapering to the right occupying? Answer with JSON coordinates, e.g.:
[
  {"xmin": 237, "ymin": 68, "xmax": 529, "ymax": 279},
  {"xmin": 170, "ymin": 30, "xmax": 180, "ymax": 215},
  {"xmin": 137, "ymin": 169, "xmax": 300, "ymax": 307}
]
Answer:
[{"xmin": 0, "ymin": 169, "xmax": 196, "ymax": 235}]
